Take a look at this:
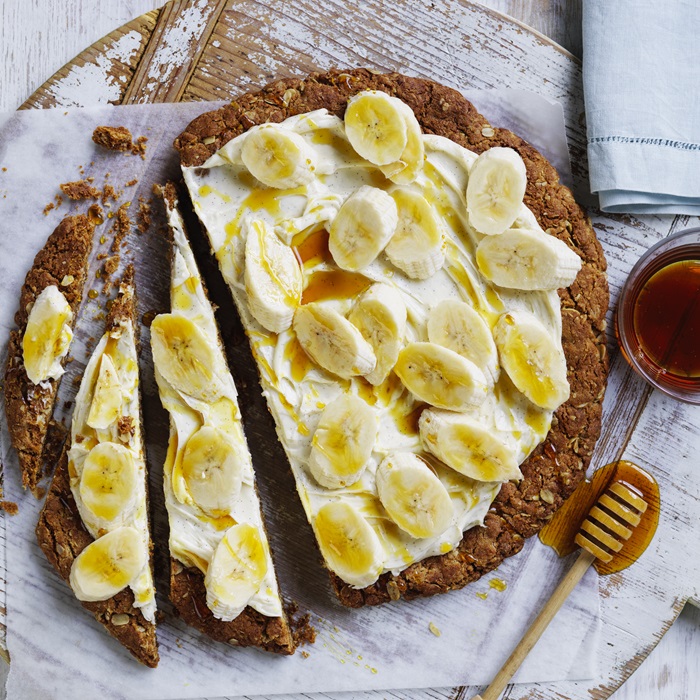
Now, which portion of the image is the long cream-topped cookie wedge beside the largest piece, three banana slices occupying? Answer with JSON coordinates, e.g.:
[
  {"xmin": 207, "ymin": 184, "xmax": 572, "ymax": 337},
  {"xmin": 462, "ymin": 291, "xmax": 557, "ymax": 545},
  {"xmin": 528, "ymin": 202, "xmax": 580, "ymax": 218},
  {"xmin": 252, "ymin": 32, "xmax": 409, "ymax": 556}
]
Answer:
[{"xmin": 151, "ymin": 185, "xmax": 295, "ymax": 654}]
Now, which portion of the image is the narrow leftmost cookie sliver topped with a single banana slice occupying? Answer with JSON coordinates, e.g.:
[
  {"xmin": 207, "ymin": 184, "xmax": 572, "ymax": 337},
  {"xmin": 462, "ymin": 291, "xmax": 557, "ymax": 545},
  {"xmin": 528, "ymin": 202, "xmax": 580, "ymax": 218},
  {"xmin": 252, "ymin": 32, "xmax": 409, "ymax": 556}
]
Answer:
[{"xmin": 5, "ymin": 214, "xmax": 95, "ymax": 490}]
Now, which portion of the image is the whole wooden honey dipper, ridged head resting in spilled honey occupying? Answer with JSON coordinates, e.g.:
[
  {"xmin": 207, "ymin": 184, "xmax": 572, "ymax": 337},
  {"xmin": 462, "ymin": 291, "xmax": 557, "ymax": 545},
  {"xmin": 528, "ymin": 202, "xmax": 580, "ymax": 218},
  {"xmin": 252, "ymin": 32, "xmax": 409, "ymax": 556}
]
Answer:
[{"xmin": 472, "ymin": 465, "xmax": 656, "ymax": 700}]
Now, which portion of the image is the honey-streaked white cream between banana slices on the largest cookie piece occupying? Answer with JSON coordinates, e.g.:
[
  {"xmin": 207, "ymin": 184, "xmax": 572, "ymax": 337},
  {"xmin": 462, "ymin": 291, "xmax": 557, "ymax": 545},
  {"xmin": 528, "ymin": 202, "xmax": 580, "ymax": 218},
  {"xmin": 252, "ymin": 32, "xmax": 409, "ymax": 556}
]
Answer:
[{"xmin": 183, "ymin": 110, "xmax": 561, "ymax": 584}]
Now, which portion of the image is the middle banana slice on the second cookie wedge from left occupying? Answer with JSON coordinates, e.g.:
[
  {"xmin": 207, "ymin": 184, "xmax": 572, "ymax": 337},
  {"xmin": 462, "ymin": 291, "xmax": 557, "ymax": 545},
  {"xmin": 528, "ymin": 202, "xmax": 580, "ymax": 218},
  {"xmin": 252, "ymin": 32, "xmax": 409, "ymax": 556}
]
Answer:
[{"xmin": 79, "ymin": 442, "xmax": 139, "ymax": 522}]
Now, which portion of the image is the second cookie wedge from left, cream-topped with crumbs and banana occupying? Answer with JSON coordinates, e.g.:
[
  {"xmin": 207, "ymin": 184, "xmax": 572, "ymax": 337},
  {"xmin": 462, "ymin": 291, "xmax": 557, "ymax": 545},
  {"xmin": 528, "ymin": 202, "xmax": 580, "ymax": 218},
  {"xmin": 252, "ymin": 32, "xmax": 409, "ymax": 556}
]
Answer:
[{"xmin": 36, "ymin": 267, "xmax": 158, "ymax": 667}]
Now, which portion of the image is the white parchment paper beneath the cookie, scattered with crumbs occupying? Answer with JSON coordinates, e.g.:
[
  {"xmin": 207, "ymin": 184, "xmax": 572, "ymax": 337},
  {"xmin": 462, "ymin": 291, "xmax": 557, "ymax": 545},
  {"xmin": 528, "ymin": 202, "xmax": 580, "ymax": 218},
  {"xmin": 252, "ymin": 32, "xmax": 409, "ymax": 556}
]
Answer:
[{"xmin": 0, "ymin": 91, "xmax": 599, "ymax": 700}]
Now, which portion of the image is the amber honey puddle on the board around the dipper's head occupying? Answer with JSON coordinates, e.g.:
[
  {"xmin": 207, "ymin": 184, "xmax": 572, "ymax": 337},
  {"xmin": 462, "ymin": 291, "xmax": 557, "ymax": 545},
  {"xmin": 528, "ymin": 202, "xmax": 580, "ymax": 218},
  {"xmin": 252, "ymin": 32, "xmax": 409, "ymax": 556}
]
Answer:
[{"xmin": 539, "ymin": 461, "xmax": 660, "ymax": 574}]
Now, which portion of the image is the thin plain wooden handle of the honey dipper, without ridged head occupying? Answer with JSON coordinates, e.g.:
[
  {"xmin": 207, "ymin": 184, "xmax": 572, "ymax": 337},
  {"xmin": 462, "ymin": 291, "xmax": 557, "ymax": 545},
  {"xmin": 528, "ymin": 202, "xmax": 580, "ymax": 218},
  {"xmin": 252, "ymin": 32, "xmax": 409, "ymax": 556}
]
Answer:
[{"xmin": 472, "ymin": 549, "xmax": 595, "ymax": 700}]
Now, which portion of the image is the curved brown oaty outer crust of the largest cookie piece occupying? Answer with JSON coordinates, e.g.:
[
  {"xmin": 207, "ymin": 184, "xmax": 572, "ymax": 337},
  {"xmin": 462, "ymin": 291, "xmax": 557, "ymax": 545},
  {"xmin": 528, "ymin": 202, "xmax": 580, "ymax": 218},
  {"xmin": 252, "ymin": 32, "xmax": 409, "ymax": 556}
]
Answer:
[{"xmin": 175, "ymin": 70, "xmax": 608, "ymax": 607}]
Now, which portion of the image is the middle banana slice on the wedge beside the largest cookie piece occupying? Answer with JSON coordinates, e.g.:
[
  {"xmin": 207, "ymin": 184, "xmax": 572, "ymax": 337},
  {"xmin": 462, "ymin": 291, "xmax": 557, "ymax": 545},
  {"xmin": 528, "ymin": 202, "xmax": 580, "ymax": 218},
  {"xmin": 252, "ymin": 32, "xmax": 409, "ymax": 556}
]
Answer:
[{"xmin": 180, "ymin": 425, "xmax": 242, "ymax": 518}]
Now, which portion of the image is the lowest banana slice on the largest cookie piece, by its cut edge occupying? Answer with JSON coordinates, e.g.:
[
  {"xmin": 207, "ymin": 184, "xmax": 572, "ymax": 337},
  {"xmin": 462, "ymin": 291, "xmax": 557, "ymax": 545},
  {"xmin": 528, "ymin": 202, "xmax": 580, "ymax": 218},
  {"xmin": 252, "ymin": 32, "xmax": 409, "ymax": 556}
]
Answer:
[{"xmin": 314, "ymin": 501, "xmax": 384, "ymax": 588}]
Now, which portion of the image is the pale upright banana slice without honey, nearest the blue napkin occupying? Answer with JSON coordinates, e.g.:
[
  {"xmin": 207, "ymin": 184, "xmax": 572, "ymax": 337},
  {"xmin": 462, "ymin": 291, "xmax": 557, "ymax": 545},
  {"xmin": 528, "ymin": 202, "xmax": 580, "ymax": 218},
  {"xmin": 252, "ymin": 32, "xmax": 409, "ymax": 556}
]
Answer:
[{"xmin": 467, "ymin": 147, "xmax": 527, "ymax": 235}]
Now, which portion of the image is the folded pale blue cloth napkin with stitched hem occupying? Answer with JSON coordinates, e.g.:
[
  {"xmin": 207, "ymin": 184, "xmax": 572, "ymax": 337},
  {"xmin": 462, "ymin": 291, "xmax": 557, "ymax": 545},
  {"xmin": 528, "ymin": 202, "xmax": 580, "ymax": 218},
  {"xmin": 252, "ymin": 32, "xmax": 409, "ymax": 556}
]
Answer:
[{"xmin": 583, "ymin": 0, "xmax": 700, "ymax": 215}]
